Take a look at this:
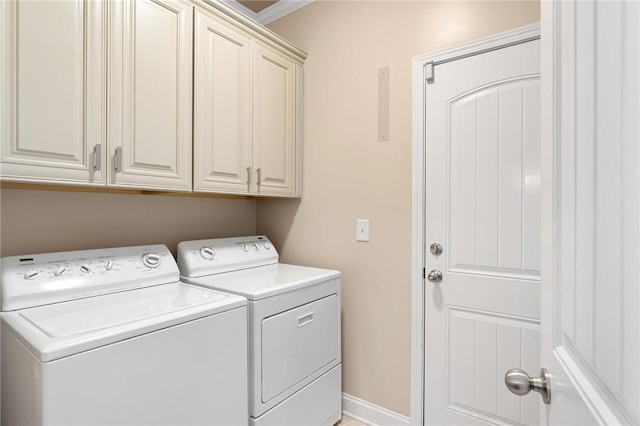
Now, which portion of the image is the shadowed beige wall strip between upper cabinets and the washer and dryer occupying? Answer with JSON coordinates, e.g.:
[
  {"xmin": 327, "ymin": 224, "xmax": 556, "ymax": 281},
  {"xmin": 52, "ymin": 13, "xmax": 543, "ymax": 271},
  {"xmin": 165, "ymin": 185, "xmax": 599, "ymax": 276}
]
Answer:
[{"xmin": 0, "ymin": 189, "xmax": 256, "ymax": 256}]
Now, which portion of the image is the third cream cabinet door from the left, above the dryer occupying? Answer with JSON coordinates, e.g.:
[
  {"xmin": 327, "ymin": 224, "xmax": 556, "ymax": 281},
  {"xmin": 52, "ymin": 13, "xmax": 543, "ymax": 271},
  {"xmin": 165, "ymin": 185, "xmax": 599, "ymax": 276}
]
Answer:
[{"xmin": 193, "ymin": 11, "xmax": 252, "ymax": 194}]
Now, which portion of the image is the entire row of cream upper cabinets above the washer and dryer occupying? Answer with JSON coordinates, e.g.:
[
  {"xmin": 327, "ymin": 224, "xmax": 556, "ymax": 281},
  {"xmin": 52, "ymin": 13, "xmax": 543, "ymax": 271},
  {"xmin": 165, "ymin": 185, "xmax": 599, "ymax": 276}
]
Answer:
[{"xmin": 0, "ymin": 0, "xmax": 306, "ymax": 197}]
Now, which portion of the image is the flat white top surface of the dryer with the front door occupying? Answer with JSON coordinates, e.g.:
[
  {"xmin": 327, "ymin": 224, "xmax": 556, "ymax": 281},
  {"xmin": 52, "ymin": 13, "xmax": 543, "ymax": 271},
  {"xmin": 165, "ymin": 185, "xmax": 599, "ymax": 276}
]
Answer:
[{"xmin": 182, "ymin": 263, "xmax": 340, "ymax": 300}]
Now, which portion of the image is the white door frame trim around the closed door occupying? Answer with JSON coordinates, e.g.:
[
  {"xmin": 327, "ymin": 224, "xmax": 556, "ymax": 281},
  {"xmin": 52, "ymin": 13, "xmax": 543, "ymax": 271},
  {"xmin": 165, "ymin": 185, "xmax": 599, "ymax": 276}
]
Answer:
[{"xmin": 411, "ymin": 24, "xmax": 540, "ymax": 425}]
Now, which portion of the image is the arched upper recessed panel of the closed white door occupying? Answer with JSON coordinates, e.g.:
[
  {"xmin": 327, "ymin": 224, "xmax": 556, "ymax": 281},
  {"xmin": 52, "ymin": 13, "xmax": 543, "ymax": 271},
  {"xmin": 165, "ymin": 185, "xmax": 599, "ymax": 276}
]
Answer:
[{"xmin": 447, "ymin": 78, "xmax": 540, "ymax": 276}]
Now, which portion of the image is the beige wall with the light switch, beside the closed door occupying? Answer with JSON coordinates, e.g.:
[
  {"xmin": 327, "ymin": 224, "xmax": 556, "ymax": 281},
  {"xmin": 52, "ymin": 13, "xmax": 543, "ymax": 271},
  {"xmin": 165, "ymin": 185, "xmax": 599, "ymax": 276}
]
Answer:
[{"xmin": 257, "ymin": 1, "xmax": 539, "ymax": 415}]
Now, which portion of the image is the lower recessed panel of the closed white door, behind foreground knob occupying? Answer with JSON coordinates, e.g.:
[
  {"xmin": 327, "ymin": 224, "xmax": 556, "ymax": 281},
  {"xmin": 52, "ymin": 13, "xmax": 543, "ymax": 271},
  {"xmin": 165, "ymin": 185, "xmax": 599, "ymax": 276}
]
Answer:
[{"xmin": 446, "ymin": 306, "xmax": 540, "ymax": 425}]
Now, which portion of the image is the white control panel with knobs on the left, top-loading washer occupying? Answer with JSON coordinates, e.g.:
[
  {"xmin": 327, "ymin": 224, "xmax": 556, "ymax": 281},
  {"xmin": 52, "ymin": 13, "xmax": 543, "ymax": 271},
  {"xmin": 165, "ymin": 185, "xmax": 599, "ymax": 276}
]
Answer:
[{"xmin": 1, "ymin": 245, "xmax": 180, "ymax": 311}]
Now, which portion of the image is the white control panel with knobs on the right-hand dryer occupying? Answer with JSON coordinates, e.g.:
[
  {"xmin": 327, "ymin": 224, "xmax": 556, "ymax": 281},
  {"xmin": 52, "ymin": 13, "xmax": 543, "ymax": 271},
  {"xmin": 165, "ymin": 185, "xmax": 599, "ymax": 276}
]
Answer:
[{"xmin": 178, "ymin": 235, "xmax": 278, "ymax": 278}]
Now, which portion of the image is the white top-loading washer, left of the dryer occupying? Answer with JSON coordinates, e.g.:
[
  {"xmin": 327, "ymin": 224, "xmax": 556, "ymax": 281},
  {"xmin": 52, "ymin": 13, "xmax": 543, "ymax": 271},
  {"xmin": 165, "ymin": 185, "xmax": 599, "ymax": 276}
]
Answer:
[{"xmin": 0, "ymin": 245, "xmax": 248, "ymax": 425}]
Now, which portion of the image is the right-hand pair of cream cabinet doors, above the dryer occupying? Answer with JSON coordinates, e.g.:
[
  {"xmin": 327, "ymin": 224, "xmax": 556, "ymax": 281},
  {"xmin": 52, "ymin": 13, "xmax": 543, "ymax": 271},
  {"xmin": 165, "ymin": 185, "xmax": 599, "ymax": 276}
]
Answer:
[{"xmin": 194, "ymin": 10, "xmax": 302, "ymax": 197}]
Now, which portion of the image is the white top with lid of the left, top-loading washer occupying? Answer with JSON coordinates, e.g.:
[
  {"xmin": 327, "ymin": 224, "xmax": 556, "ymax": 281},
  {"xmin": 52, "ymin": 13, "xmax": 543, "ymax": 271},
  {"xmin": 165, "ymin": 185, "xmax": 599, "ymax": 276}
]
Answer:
[{"xmin": 2, "ymin": 283, "xmax": 246, "ymax": 362}]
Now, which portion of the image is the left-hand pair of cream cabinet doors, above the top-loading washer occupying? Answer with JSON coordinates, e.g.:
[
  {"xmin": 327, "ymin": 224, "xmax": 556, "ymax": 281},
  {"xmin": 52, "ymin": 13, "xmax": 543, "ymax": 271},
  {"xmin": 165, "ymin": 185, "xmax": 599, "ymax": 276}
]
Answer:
[{"xmin": 0, "ymin": 0, "xmax": 193, "ymax": 191}]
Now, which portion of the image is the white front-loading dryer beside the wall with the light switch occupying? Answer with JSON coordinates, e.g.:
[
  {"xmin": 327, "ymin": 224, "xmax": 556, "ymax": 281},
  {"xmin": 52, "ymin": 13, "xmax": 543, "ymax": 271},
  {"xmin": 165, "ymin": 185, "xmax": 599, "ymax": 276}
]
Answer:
[{"xmin": 178, "ymin": 236, "xmax": 342, "ymax": 426}]
